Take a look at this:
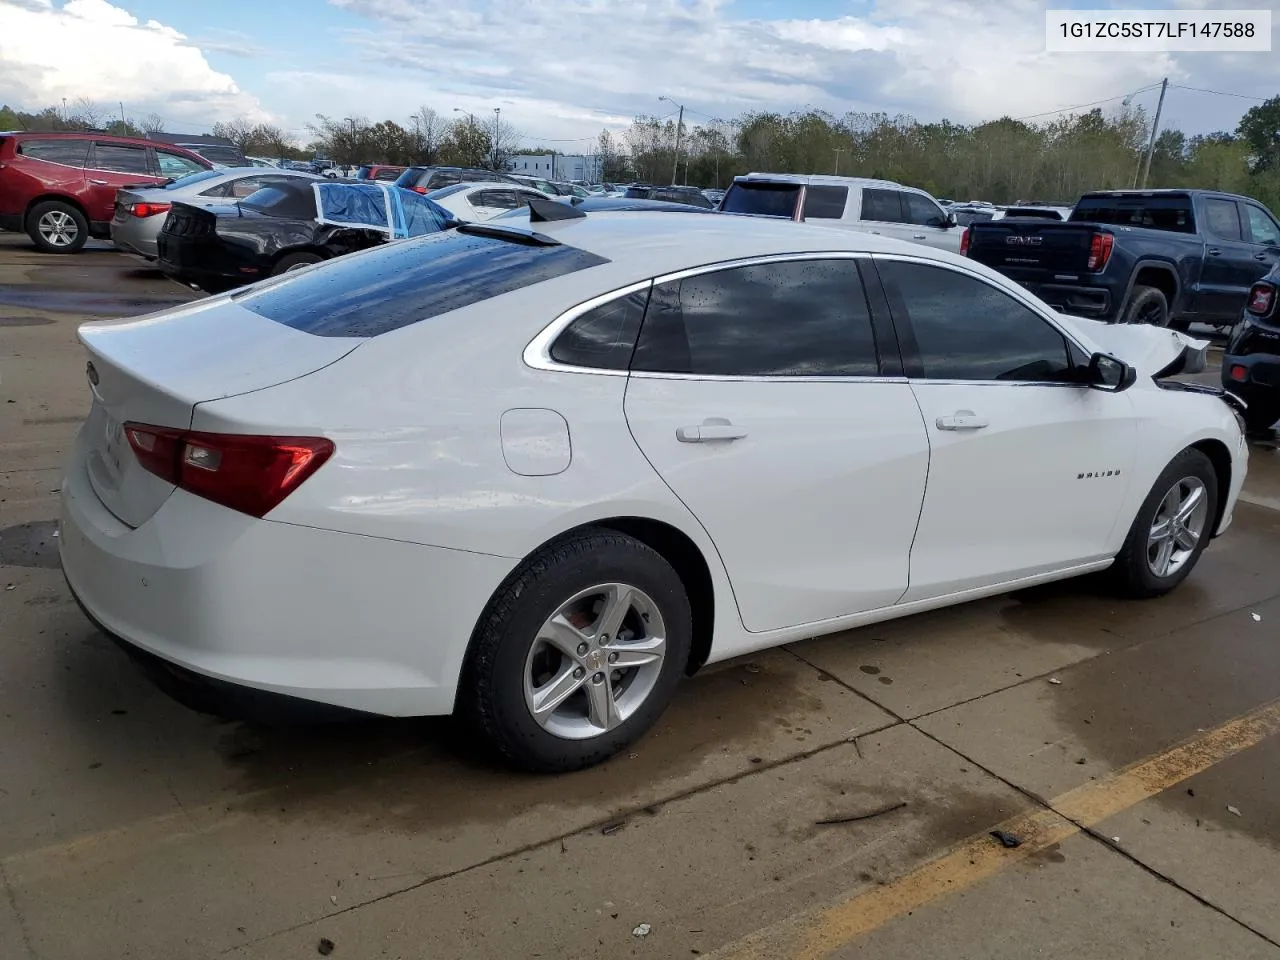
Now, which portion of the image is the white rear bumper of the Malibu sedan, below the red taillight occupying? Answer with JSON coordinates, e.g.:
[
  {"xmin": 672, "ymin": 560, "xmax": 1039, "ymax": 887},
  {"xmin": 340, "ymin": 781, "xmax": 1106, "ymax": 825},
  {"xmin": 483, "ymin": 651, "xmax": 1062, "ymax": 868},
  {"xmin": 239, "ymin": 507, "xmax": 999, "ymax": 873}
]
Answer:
[{"xmin": 59, "ymin": 442, "xmax": 516, "ymax": 717}]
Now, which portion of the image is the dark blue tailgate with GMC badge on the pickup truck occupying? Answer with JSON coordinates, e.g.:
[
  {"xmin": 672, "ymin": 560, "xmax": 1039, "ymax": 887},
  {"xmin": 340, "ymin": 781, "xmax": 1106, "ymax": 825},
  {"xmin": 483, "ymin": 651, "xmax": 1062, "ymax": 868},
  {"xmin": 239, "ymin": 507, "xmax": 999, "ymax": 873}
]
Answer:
[{"xmin": 969, "ymin": 218, "xmax": 1098, "ymax": 273}]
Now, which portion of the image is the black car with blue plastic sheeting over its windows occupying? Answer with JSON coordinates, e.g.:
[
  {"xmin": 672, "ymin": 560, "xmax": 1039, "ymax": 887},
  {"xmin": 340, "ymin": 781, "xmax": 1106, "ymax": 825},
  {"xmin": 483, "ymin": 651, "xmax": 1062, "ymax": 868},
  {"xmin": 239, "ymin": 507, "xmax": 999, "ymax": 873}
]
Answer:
[{"xmin": 157, "ymin": 180, "xmax": 454, "ymax": 293}]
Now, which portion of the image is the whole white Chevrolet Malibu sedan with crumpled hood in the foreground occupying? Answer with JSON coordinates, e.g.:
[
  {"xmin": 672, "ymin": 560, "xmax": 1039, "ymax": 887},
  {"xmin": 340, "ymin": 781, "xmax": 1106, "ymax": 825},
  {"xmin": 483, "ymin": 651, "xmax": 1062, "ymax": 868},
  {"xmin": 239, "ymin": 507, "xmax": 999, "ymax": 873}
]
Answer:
[{"xmin": 59, "ymin": 204, "xmax": 1247, "ymax": 771}]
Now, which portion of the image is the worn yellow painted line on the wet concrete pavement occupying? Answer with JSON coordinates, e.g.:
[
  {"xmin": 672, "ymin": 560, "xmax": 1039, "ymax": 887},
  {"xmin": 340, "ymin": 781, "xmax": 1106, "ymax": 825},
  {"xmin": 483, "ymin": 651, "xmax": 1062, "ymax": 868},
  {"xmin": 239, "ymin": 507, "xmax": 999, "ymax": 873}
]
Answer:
[{"xmin": 710, "ymin": 700, "xmax": 1280, "ymax": 960}]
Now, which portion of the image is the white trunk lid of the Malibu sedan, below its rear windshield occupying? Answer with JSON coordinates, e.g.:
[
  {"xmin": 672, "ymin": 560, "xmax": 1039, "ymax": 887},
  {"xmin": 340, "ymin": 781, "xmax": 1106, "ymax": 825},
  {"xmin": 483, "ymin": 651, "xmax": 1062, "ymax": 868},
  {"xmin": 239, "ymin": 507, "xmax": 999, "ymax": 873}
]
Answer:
[{"xmin": 79, "ymin": 297, "xmax": 364, "ymax": 527}]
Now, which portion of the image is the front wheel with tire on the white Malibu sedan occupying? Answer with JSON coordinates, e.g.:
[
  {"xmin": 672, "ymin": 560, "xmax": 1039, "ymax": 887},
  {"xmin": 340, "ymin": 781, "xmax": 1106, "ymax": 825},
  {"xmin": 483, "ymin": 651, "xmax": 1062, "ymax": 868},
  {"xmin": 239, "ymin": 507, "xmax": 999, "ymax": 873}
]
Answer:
[{"xmin": 1107, "ymin": 449, "xmax": 1217, "ymax": 599}]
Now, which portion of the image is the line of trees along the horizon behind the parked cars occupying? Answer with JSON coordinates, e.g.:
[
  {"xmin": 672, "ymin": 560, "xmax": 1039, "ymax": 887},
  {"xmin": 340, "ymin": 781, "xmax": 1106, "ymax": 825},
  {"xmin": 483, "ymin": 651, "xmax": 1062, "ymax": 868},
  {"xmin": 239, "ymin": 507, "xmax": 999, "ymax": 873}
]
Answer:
[{"xmin": 0, "ymin": 96, "xmax": 1280, "ymax": 211}]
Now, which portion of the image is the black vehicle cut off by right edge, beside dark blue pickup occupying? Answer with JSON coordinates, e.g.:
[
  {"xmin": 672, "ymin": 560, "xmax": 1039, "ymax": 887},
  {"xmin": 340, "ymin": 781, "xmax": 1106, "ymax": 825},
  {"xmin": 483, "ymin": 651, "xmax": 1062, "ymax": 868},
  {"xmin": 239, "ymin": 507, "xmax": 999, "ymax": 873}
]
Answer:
[{"xmin": 1222, "ymin": 264, "xmax": 1280, "ymax": 433}]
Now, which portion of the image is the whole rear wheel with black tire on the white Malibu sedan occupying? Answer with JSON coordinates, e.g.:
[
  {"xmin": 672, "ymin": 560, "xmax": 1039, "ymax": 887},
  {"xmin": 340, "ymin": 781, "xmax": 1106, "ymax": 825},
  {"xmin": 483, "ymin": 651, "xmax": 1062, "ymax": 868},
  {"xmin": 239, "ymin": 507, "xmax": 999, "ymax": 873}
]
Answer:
[{"xmin": 460, "ymin": 529, "xmax": 692, "ymax": 773}]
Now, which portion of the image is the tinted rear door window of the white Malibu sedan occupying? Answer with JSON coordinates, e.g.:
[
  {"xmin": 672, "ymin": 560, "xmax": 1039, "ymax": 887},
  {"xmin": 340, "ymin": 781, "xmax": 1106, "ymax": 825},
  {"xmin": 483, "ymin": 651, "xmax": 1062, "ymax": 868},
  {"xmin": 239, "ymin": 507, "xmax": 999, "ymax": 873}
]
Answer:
[{"xmin": 631, "ymin": 260, "xmax": 878, "ymax": 376}]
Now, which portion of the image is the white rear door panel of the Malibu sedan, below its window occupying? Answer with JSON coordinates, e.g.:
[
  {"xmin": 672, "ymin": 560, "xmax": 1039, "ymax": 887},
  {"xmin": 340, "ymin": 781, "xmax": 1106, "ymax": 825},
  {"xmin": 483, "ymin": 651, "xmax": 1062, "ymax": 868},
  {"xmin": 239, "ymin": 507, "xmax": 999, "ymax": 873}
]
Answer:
[{"xmin": 625, "ymin": 375, "xmax": 928, "ymax": 631}]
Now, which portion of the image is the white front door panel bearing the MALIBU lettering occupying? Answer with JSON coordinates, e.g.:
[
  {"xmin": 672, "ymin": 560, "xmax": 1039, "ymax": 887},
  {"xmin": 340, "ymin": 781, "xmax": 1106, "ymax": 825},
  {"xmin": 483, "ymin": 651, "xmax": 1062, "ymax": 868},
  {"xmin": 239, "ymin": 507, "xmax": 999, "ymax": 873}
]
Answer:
[{"xmin": 902, "ymin": 380, "xmax": 1138, "ymax": 603}]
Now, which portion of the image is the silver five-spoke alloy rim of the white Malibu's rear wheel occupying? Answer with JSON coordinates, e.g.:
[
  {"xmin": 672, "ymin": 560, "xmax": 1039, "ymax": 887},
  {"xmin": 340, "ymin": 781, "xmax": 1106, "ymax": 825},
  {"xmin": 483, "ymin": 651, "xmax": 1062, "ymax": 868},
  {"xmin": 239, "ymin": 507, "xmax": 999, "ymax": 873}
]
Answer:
[{"xmin": 524, "ymin": 584, "xmax": 667, "ymax": 740}]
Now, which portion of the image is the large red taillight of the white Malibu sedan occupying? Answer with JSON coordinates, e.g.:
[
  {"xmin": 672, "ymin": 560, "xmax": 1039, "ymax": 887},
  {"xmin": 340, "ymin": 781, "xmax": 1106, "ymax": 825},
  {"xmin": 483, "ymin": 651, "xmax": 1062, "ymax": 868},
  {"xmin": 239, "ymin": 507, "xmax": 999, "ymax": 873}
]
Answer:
[{"xmin": 124, "ymin": 422, "xmax": 334, "ymax": 517}]
